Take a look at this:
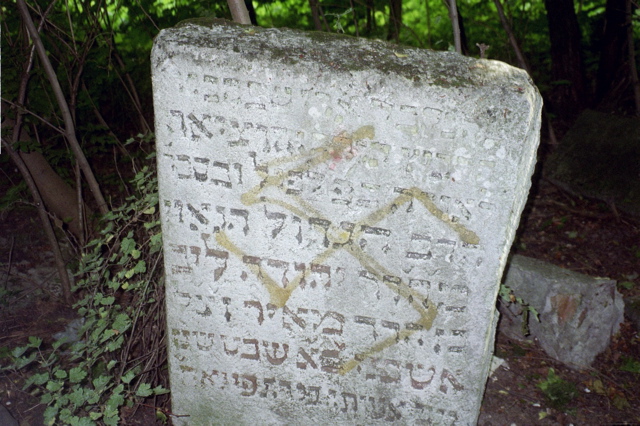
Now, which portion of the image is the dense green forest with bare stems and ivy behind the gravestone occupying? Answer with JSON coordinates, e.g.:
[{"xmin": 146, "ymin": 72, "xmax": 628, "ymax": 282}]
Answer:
[{"xmin": 0, "ymin": 0, "xmax": 640, "ymax": 424}]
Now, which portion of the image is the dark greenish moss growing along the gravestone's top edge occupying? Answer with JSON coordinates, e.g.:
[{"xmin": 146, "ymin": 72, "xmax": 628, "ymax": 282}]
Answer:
[{"xmin": 170, "ymin": 18, "xmax": 477, "ymax": 88}]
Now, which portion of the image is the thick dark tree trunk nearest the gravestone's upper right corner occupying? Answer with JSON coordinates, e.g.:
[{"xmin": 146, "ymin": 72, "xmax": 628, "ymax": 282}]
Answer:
[{"xmin": 544, "ymin": 0, "xmax": 587, "ymax": 114}]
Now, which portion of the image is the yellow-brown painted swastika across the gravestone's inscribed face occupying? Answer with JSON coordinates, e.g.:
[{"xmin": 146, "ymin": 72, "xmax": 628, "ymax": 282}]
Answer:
[{"xmin": 216, "ymin": 125, "xmax": 480, "ymax": 374}]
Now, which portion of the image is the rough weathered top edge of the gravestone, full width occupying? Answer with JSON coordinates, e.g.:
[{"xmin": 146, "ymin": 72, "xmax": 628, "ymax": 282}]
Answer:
[{"xmin": 158, "ymin": 18, "xmax": 533, "ymax": 93}]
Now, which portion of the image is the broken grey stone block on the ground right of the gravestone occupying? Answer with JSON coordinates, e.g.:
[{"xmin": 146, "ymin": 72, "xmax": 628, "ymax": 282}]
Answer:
[{"xmin": 500, "ymin": 255, "xmax": 624, "ymax": 368}]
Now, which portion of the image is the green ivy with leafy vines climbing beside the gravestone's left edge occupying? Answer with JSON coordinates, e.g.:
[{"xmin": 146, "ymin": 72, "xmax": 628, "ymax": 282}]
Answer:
[{"xmin": 5, "ymin": 144, "xmax": 169, "ymax": 425}]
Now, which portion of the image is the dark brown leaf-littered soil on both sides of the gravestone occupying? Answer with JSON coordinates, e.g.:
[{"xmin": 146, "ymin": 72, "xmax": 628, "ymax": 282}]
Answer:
[{"xmin": 0, "ymin": 148, "xmax": 640, "ymax": 426}]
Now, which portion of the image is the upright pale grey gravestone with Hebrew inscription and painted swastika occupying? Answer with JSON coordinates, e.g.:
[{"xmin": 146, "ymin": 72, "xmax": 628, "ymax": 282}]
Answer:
[{"xmin": 152, "ymin": 20, "xmax": 541, "ymax": 425}]
